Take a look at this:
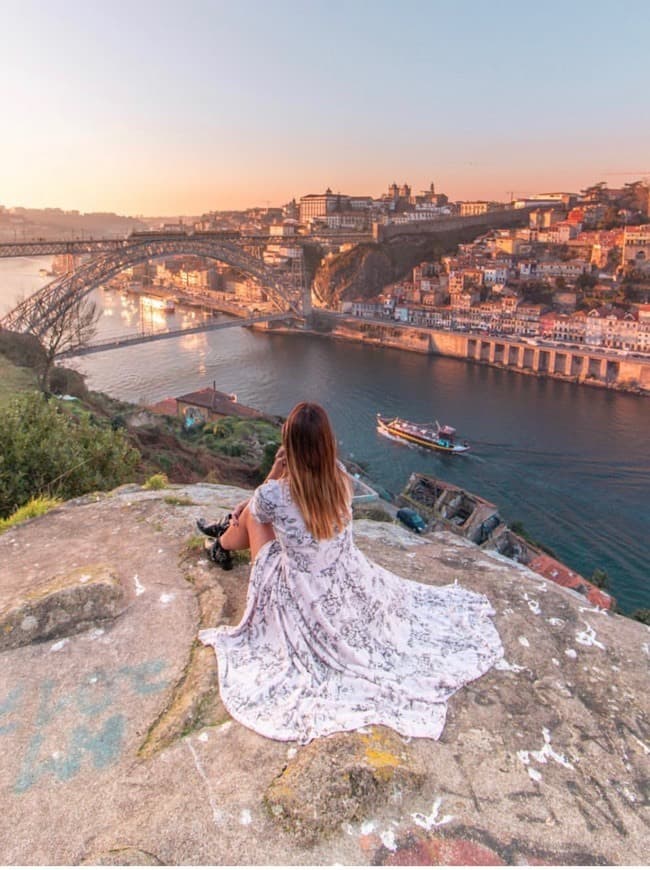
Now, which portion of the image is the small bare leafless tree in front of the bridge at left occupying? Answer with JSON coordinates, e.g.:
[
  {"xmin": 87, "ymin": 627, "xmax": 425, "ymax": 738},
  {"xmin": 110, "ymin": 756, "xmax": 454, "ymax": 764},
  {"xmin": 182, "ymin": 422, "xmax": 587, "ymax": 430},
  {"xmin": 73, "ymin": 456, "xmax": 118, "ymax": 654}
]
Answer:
[{"xmin": 29, "ymin": 296, "xmax": 101, "ymax": 393}]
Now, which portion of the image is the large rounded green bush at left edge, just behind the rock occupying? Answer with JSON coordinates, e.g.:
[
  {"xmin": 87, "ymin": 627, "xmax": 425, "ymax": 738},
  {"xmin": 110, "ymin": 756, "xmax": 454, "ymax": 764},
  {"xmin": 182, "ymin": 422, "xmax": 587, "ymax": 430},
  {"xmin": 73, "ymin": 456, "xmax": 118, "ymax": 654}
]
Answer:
[{"xmin": 0, "ymin": 392, "xmax": 140, "ymax": 517}]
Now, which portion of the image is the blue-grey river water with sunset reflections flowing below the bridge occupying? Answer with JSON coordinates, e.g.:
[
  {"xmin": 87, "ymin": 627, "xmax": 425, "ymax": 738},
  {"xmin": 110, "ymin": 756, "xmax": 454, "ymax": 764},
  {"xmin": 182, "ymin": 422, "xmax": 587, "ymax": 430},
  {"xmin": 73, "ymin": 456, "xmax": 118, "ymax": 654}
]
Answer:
[{"xmin": 0, "ymin": 259, "xmax": 650, "ymax": 612}]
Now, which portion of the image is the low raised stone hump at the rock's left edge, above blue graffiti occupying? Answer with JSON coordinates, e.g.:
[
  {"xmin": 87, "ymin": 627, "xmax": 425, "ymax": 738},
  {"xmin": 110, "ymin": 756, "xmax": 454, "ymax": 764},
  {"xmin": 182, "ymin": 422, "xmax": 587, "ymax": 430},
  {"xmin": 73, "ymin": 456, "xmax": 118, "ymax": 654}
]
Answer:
[{"xmin": 0, "ymin": 564, "xmax": 127, "ymax": 651}]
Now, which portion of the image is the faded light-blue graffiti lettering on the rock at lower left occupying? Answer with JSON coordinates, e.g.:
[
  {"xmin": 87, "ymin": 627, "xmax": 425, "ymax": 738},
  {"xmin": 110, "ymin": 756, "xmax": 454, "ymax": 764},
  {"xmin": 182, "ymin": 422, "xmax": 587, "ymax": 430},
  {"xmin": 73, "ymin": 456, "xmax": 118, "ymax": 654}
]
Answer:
[{"xmin": 5, "ymin": 659, "xmax": 169, "ymax": 794}]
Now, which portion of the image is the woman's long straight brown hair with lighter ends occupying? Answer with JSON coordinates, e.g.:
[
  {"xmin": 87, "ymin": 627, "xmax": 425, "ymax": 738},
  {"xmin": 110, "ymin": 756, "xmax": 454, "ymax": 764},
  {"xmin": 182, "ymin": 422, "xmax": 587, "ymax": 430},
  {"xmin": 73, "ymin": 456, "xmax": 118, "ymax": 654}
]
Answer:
[{"xmin": 282, "ymin": 402, "xmax": 351, "ymax": 541}]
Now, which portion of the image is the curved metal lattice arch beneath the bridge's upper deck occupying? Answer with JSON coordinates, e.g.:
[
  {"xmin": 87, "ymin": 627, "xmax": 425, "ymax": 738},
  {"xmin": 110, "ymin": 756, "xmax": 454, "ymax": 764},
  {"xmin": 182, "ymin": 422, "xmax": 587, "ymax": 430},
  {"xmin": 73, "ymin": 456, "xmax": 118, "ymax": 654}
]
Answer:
[{"xmin": 0, "ymin": 236, "xmax": 301, "ymax": 336}]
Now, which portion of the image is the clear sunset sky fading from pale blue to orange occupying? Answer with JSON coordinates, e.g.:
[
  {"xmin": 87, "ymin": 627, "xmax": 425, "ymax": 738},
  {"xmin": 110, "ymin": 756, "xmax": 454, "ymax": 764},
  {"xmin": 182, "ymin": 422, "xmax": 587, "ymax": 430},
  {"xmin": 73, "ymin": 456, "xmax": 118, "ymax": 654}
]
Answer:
[{"xmin": 0, "ymin": 0, "xmax": 650, "ymax": 215}]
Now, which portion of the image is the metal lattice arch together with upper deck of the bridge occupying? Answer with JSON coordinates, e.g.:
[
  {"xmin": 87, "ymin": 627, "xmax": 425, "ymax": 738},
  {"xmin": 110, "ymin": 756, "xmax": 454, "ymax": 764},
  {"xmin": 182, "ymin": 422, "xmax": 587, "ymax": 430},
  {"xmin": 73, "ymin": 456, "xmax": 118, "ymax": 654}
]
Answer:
[{"xmin": 0, "ymin": 233, "xmax": 309, "ymax": 337}]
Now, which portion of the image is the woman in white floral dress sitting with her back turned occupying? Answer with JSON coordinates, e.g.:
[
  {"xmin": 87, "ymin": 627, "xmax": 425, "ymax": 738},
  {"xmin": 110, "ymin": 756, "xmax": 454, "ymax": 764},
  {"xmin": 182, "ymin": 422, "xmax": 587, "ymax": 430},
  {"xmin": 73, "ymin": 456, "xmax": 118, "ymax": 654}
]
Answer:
[{"xmin": 199, "ymin": 402, "xmax": 503, "ymax": 743}]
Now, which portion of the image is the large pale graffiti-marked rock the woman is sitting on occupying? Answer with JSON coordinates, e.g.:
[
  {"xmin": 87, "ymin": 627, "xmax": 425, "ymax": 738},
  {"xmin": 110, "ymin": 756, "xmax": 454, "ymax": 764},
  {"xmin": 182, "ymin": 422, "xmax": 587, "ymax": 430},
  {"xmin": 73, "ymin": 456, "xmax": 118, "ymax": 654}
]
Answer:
[{"xmin": 0, "ymin": 484, "xmax": 650, "ymax": 865}]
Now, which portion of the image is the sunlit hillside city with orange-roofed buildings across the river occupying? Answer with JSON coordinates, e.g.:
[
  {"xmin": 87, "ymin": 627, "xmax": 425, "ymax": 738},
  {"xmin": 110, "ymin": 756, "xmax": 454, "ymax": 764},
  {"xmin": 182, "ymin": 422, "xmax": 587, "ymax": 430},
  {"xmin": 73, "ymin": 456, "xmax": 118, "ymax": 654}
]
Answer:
[{"xmin": 0, "ymin": 179, "xmax": 650, "ymax": 355}]
